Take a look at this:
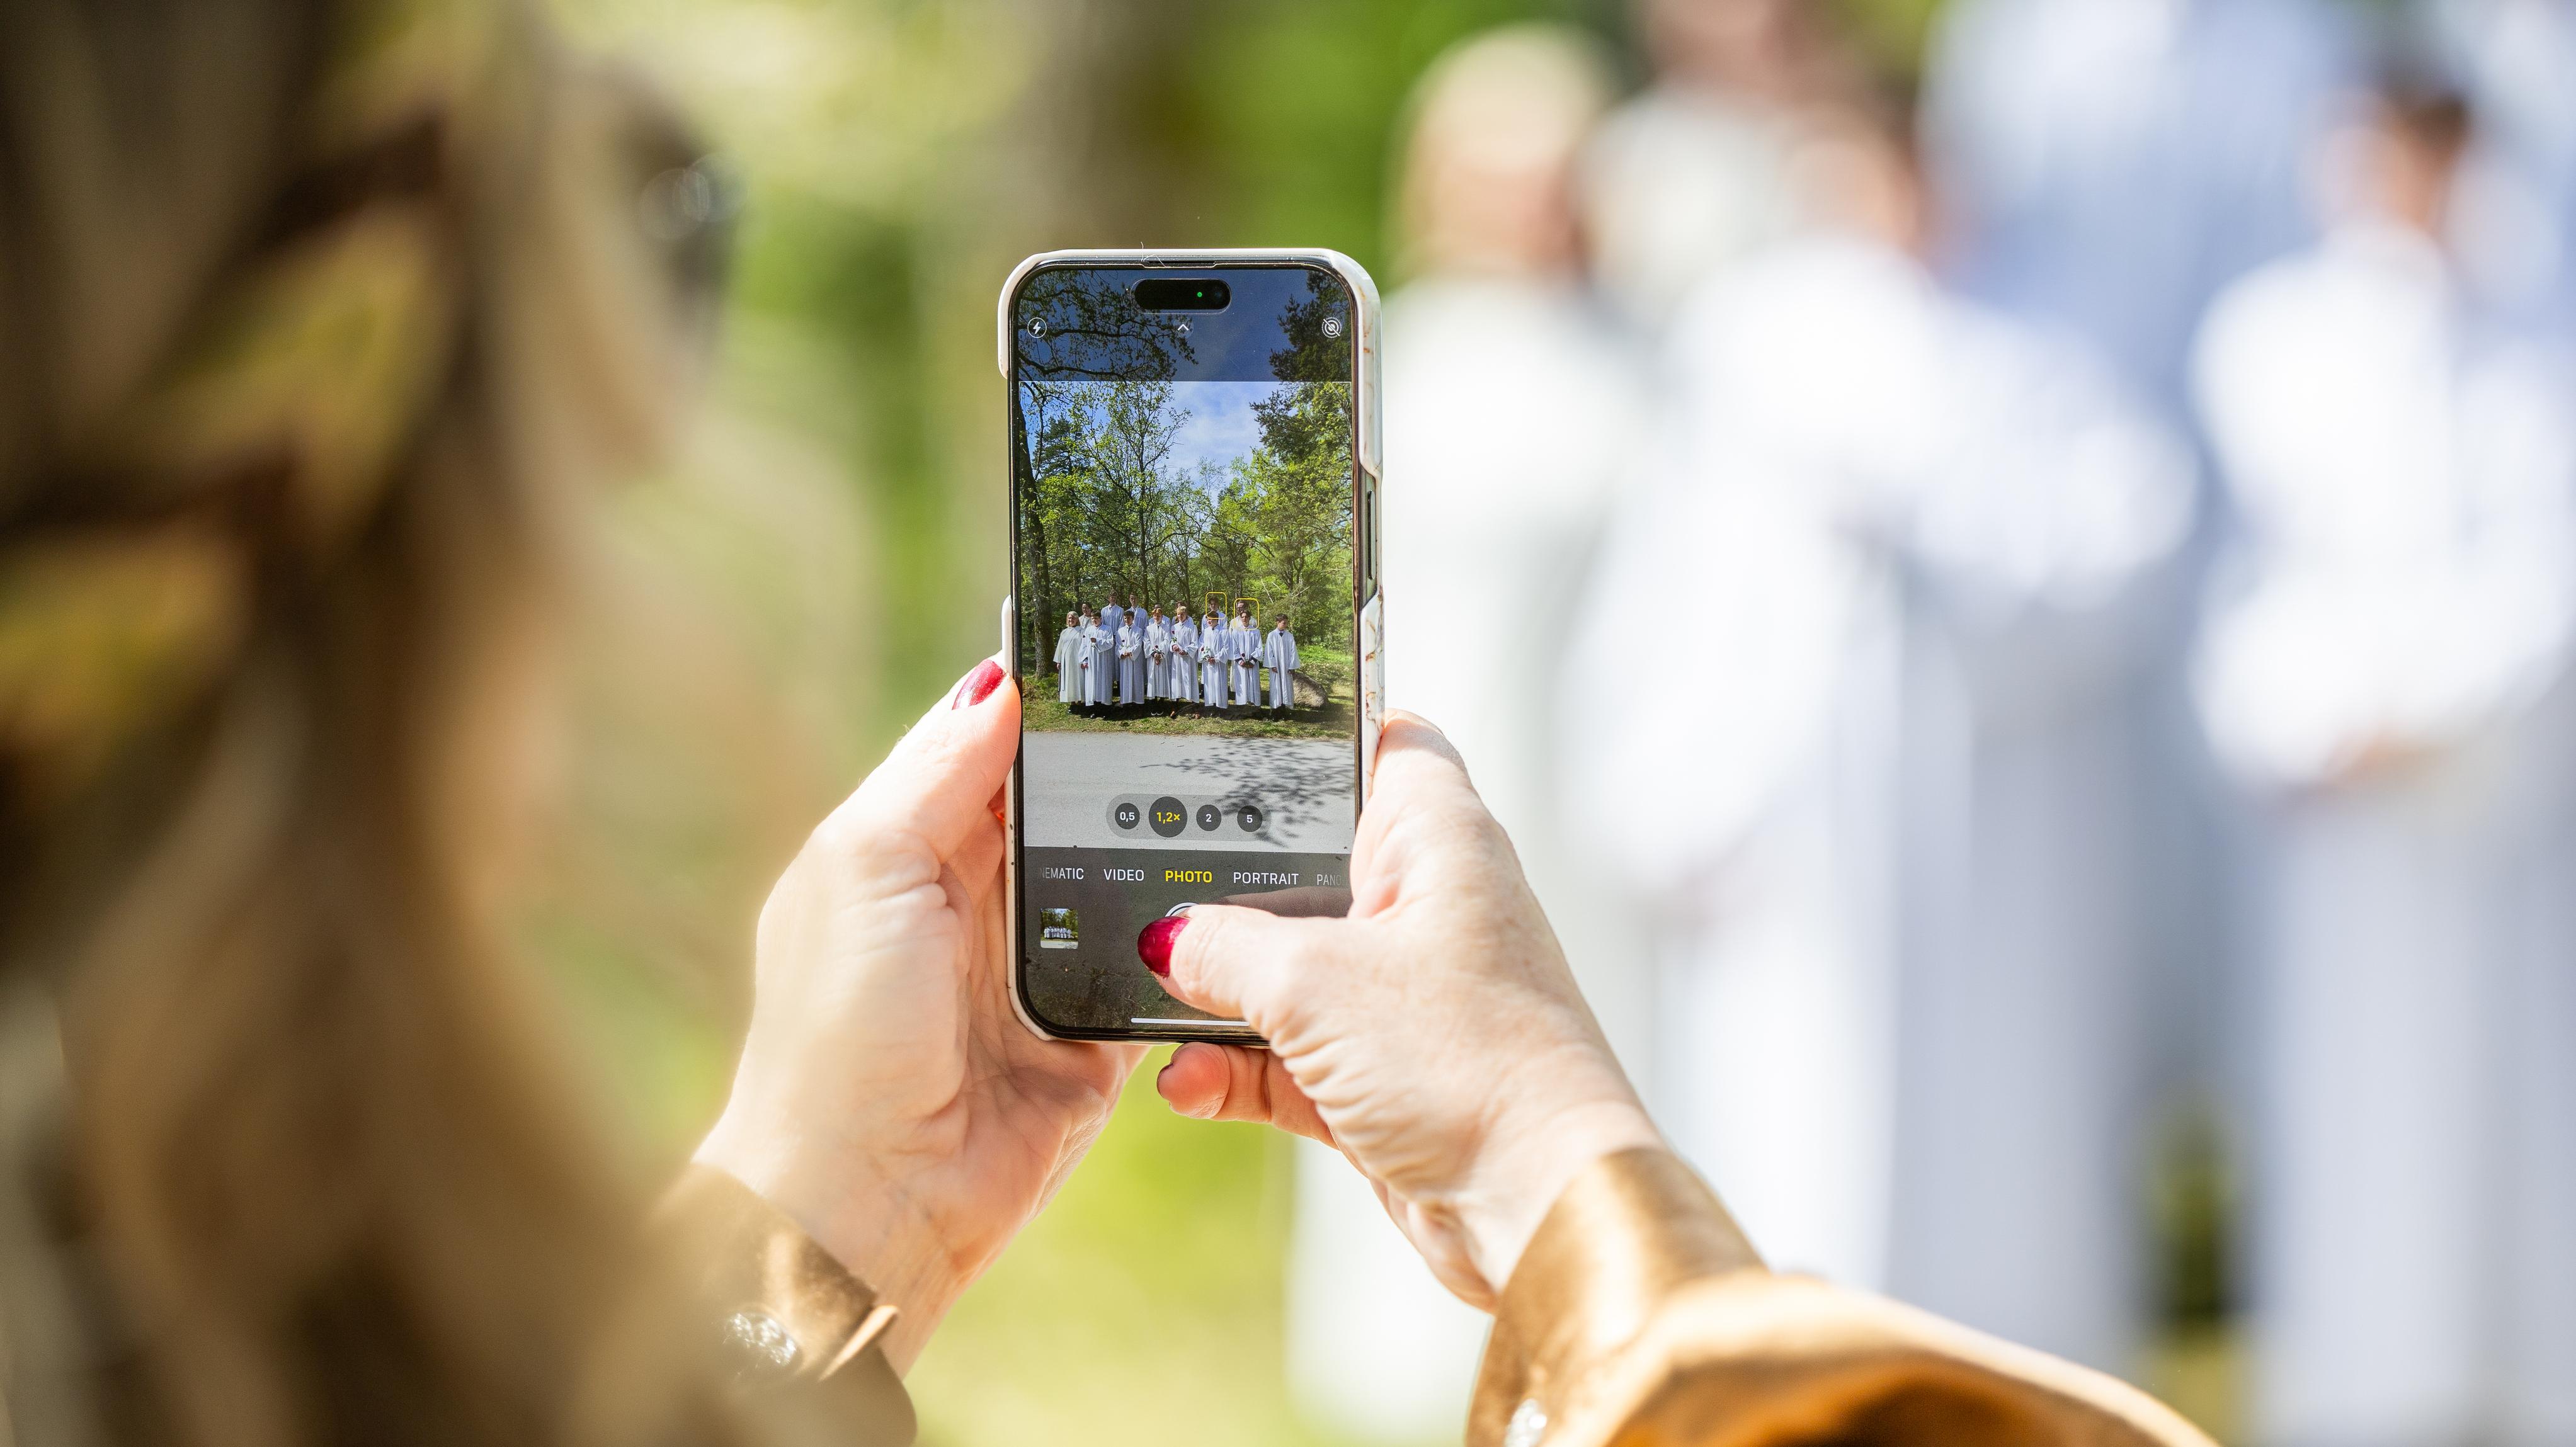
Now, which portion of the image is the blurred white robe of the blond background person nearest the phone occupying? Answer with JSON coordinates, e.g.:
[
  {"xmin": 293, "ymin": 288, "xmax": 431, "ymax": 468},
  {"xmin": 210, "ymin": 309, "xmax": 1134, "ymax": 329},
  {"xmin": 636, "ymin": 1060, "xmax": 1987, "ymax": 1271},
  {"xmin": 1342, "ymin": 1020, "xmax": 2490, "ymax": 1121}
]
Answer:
[{"xmin": 1288, "ymin": 281, "xmax": 1651, "ymax": 1442}]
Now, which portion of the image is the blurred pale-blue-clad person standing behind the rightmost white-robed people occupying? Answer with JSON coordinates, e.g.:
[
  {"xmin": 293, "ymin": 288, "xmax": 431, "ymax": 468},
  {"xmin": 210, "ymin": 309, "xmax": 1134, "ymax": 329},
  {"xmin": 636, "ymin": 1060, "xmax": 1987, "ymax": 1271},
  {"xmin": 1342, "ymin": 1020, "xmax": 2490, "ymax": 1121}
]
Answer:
[{"xmin": 1922, "ymin": 0, "xmax": 2359, "ymax": 1359}]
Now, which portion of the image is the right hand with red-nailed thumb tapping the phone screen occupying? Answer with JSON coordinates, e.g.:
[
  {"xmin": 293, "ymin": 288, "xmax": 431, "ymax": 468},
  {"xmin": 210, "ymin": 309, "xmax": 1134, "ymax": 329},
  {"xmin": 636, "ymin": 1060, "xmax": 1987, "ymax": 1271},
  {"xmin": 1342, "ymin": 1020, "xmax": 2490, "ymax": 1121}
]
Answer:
[{"xmin": 1154, "ymin": 713, "xmax": 1659, "ymax": 1308}]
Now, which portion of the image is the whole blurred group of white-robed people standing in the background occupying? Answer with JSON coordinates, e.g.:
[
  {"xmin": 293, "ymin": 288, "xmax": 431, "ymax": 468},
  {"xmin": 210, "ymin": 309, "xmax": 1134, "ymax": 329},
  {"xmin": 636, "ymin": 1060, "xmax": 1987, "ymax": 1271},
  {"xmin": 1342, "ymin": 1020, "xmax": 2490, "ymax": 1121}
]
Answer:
[{"xmin": 1288, "ymin": 0, "xmax": 2576, "ymax": 1447}]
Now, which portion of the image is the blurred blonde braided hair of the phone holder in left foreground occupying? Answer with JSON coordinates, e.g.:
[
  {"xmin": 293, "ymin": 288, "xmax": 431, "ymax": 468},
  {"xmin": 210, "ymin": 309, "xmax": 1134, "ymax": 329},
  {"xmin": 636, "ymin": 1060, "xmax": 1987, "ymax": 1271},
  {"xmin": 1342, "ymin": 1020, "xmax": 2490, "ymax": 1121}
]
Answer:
[{"xmin": 0, "ymin": 0, "xmax": 752, "ymax": 1444}]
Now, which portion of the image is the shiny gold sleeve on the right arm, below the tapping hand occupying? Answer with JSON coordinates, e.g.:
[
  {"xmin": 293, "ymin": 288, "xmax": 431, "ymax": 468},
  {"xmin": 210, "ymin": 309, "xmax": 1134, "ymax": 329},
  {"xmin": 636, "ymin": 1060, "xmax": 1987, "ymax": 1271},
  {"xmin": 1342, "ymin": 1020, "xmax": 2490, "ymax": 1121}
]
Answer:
[{"xmin": 1466, "ymin": 1149, "xmax": 2210, "ymax": 1447}]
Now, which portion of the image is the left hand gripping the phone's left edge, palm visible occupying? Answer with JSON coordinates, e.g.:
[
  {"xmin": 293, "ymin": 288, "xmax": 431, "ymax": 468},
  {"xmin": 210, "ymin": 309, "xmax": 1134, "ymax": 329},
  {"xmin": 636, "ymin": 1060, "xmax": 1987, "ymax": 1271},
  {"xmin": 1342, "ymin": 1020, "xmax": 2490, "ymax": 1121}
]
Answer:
[{"xmin": 698, "ymin": 659, "xmax": 1144, "ymax": 1370}]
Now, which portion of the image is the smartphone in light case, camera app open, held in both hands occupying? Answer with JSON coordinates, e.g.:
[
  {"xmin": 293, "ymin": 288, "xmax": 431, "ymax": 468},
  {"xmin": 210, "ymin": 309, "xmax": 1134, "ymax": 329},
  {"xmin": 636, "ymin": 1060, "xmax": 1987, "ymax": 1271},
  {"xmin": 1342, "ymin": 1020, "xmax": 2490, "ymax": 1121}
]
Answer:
[{"xmin": 1000, "ymin": 250, "xmax": 1386, "ymax": 1043}]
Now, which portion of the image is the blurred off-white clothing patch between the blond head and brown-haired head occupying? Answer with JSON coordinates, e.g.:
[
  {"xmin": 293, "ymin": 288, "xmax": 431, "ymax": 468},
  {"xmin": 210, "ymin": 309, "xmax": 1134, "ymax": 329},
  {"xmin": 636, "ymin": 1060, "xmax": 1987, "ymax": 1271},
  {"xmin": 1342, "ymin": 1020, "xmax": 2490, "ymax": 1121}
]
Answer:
[{"xmin": 1579, "ymin": 85, "xmax": 1798, "ymax": 338}]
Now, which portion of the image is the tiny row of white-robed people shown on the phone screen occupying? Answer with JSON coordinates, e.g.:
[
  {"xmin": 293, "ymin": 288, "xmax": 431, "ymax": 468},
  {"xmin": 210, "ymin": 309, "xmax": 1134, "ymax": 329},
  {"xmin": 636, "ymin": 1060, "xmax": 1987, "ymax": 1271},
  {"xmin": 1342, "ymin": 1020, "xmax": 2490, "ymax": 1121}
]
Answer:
[{"xmin": 1054, "ymin": 595, "xmax": 1304, "ymax": 713}]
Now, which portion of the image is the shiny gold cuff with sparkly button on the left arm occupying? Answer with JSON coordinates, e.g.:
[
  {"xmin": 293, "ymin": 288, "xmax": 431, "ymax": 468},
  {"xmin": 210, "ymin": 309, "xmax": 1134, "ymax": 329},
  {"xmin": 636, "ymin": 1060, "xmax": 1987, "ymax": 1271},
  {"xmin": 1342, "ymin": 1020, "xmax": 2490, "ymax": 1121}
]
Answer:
[{"xmin": 654, "ymin": 1166, "xmax": 915, "ymax": 1447}]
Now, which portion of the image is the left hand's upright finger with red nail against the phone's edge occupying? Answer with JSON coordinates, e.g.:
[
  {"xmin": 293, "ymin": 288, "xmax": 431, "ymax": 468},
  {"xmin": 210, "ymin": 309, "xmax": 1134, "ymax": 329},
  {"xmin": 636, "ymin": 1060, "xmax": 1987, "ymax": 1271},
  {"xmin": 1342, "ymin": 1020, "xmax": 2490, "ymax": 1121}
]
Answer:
[{"xmin": 832, "ymin": 659, "xmax": 1020, "ymax": 858}]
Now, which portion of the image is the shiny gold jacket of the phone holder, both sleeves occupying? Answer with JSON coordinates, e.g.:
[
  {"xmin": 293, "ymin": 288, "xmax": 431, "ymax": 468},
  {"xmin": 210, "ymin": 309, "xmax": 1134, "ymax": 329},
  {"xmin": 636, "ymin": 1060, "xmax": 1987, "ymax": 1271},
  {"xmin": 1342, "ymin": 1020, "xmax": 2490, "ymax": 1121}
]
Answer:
[{"xmin": 672, "ymin": 1151, "xmax": 2208, "ymax": 1447}]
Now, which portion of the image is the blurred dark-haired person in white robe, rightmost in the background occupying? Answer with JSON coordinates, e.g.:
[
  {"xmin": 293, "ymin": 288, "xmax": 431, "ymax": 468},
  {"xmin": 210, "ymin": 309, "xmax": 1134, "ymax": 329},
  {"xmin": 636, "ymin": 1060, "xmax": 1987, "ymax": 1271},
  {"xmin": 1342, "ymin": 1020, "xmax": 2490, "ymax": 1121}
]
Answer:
[{"xmin": 2192, "ymin": 88, "xmax": 2576, "ymax": 1447}]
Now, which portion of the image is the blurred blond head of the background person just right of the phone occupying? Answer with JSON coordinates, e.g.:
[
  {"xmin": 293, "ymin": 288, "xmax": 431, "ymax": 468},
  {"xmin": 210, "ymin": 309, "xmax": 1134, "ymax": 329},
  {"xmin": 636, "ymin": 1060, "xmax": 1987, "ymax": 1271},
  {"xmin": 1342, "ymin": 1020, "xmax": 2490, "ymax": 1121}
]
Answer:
[{"xmin": 1394, "ymin": 23, "xmax": 1615, "ymax": 276}]
